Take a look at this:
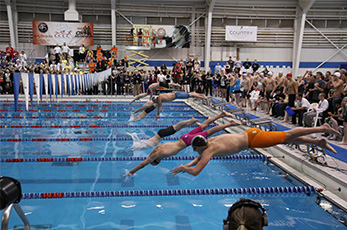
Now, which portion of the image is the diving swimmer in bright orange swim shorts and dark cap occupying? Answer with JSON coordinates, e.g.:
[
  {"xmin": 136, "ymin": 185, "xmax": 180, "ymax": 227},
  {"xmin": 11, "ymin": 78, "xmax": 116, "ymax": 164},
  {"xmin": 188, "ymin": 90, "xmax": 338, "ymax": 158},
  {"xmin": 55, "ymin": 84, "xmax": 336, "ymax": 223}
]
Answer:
[{"xmin": 171, "ymin": 123, "xmax": 341, "ymax": 176}]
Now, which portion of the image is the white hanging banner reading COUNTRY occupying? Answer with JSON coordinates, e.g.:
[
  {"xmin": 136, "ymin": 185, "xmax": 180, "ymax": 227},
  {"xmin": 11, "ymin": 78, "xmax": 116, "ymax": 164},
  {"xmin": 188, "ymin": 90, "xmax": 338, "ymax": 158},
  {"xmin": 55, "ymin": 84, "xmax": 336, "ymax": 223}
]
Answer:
[{"xmin": 225, "ymin": 26, "xmax": 258, "ymax": 42}]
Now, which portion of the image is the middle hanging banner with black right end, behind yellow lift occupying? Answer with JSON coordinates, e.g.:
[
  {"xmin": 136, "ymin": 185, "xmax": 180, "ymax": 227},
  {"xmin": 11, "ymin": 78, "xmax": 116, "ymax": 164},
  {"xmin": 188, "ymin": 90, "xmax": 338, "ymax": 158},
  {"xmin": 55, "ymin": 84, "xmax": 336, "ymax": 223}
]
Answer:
[{"xmin": 129, "ymin": 24, "xmax": 190, "ymax": 48}]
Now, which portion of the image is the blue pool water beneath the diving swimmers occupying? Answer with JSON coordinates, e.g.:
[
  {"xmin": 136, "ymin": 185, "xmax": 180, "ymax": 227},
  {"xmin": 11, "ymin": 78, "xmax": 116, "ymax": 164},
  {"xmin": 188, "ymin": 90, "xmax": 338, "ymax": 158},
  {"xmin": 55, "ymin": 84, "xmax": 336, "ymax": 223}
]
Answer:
[{"xmin": 0, "ymin": 103, "xmax": 346, "ymax": 230}]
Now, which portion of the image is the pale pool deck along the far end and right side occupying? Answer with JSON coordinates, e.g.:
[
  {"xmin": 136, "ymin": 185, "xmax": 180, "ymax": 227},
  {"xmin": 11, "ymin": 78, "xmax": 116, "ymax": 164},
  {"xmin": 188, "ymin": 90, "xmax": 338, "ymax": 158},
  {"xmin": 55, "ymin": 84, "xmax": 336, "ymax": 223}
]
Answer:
[{"xmin": 0, "ymin": 95, "xmax": 347, "ymax": 210}]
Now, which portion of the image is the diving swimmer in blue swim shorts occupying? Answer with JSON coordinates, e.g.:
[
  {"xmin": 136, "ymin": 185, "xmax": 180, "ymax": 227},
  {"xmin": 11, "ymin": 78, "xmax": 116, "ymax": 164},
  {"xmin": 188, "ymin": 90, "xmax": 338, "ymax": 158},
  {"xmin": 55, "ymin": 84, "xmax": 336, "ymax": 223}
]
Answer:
[{"xmin": 152, "ymin": 91, "xmax": 207, "ymax": 120}]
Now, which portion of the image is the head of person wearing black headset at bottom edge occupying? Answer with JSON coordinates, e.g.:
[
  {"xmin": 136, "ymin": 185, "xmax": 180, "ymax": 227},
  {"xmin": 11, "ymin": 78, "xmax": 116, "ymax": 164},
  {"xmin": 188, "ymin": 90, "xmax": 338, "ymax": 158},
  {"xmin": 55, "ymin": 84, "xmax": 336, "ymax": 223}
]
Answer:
[{"xmin": 223, "ymin": 198, "xmax": 269, "ymax": 230}]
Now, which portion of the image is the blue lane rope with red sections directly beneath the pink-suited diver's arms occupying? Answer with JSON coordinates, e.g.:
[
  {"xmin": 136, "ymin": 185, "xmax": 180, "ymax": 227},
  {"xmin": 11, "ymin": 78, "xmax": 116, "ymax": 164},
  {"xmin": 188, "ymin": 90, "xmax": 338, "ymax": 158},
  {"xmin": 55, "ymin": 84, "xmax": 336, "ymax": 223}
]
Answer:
[{"xmin": 0, "ymin": 155, "xmax": 267, "ymax": 163}]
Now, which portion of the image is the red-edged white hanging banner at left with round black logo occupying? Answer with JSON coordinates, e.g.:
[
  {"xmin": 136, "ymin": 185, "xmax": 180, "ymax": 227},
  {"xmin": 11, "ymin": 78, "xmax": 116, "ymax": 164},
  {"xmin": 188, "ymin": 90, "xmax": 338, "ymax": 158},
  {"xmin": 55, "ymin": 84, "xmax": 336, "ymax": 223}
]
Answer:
[{"xmin": 32, "ymin": 21, "xmax": 94, "ymax": 46}]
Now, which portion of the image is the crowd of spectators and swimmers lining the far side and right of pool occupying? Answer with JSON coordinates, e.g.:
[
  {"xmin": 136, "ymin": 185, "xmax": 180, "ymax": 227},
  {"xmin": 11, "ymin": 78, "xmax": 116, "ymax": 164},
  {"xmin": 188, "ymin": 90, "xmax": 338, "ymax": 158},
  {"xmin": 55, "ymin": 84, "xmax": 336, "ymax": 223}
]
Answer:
[{"xmin": 0, "ymin": 43, "xmax": 347, "ymax": 141}]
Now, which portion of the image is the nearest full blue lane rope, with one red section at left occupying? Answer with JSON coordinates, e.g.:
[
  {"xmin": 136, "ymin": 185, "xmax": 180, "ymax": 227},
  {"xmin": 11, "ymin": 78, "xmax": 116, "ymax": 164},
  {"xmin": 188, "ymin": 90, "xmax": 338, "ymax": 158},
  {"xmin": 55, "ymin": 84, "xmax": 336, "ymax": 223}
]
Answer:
[{"xmin": 22, "ymin": 186, "xmax": 318, "ymax": 199}]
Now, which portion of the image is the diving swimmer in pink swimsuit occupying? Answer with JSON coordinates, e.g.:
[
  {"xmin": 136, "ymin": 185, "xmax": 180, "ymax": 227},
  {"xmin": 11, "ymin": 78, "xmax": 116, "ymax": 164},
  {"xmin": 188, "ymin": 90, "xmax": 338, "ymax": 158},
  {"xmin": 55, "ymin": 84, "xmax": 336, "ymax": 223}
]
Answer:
[{"xmin": 126, "ymin": 111, "xmax": 239, "ymax": 176}]
